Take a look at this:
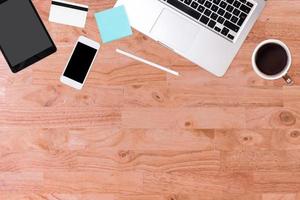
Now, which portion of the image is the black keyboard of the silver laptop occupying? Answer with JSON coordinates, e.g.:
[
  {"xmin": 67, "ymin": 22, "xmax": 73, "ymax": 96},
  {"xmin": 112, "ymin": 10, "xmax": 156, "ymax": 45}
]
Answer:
[{"xmin": 161, "ymin": 0, "xmax": 254, "ymax": 41}]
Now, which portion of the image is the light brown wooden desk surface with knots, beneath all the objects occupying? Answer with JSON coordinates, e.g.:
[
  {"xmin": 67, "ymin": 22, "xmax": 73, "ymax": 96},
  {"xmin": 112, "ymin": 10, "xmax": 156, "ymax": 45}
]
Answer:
[{"xmin": 0, "ymin": 0, "xmax": 300, "ymax": 200}]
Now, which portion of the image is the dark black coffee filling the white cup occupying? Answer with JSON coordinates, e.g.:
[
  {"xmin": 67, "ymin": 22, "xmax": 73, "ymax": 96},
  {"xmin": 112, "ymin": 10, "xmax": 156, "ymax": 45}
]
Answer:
[{"xmin": 256, "ymin": 43, "xmax": 288, "ymax": 75}]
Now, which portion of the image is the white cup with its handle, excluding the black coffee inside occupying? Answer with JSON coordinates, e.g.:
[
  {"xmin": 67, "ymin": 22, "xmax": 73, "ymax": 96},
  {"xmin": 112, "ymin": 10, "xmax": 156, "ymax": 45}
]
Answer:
[{"xmin": 252, "ymin": 39, "xmax": 294, "ymax": 85}]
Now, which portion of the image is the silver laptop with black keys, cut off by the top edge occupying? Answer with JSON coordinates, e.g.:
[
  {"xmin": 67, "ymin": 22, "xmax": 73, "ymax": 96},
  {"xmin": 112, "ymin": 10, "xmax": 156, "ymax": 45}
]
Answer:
[{"xmin": 116, "ymin": 0, "xmax": 265, "ymax": 77}]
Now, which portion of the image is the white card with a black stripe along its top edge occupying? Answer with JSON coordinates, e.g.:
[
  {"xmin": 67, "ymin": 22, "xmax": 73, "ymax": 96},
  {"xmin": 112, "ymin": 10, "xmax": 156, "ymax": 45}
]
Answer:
[{"xmin": 49, "ymin": 0, "xmax": 89, "ymax": 28}]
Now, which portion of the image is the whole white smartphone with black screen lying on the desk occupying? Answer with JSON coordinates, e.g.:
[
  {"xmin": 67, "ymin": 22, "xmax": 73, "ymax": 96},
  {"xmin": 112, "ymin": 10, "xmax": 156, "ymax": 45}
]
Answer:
[{"xmin": 60, "ymin": 36, "xmax": 100, "ymax": 90}]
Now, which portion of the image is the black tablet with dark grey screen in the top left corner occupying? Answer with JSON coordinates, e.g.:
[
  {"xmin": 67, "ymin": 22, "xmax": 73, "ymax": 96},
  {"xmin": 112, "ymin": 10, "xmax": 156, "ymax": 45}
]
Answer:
[{"xmin": 0, "ymin": 0, "xmax": 56, "ymax": 73}]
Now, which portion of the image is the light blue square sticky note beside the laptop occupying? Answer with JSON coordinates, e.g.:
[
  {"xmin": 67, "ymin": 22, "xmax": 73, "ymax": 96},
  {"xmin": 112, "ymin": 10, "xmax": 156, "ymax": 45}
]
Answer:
[{"xmin": 95, "ymin": 6, "xmax": 132, "ymax": 43}]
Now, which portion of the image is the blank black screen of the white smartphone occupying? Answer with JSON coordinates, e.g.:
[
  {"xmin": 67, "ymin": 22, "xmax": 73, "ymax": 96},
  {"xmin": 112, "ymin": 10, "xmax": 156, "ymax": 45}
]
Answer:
[{"xmin": 64, "ymin": 42, "xmax": 97, "ymax": 84}]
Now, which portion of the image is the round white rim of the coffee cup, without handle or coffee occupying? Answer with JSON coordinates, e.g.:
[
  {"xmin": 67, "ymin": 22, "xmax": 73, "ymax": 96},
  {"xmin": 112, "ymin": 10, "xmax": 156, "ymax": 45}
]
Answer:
[{"xmin": 252, "ymin": 39, "xmax": 292, "ymax": 80}]
